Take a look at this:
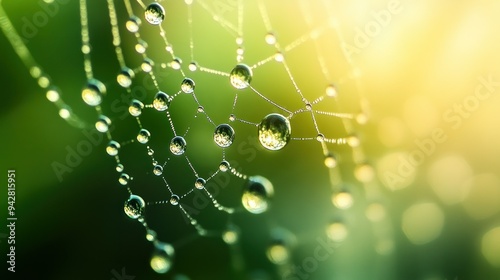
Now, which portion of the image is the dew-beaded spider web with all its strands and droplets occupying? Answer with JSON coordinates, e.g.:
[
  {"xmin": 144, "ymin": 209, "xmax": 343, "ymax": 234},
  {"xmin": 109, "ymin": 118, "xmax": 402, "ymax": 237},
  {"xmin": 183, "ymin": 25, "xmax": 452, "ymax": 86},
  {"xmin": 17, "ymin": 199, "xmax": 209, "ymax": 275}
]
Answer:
[{"xmin": 0, "ymin": 0, "xmax": 394, "ymax": 272}]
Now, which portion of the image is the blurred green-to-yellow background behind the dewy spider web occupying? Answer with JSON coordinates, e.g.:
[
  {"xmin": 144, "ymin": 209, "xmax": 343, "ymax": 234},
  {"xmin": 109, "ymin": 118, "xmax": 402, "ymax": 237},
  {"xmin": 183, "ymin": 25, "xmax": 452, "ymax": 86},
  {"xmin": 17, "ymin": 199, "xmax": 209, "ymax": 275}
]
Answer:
[{"xmin": 0, "ymin": 0, "xmax": 500, "ymax": 280}]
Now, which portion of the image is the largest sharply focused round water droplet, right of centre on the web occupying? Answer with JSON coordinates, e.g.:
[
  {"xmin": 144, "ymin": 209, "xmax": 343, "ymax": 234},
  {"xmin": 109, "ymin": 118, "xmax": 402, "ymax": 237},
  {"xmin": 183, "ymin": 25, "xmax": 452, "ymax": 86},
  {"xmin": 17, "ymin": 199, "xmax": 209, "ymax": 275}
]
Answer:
[{"xmin": 258, "ymin": 113, "xmax": 292, "ymax": 151}]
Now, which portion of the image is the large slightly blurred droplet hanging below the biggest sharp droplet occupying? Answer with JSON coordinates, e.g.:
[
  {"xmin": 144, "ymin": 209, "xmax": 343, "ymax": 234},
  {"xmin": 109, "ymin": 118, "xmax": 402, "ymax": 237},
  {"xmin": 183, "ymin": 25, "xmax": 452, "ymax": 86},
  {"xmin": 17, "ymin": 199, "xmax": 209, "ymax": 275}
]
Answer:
[{"xmin": 241, "ymin": 176, "xmax": 274, "ymax": 214}]
